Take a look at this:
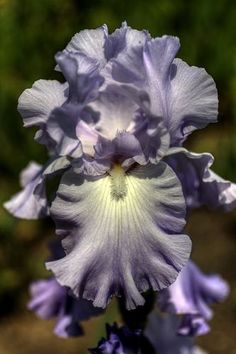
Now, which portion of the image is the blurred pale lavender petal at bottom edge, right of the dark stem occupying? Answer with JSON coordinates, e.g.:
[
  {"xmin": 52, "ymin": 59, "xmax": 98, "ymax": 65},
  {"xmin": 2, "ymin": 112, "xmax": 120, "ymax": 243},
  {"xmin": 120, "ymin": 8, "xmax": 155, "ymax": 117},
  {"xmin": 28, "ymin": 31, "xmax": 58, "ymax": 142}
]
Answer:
[{"xmin": 144, "ymin": 311, "xmax": 207, "ymax": 354}]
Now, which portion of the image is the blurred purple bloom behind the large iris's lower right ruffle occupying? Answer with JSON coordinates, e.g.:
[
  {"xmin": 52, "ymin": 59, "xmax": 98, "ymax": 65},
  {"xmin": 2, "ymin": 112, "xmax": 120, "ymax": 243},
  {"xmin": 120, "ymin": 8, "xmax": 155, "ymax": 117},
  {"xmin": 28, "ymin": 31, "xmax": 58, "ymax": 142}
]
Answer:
[{"xmin": 159, "ymin": 261, "xmax": 229, "ymax": 335}]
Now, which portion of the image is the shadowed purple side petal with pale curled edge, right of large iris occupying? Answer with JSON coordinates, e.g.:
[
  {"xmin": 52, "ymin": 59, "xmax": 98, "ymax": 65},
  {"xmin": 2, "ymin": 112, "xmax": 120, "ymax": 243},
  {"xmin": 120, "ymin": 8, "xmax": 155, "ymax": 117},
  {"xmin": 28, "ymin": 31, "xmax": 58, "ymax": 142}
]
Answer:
[{"xmin": 165, "ymin": 148, "xmax": 236, "ymax": 211}]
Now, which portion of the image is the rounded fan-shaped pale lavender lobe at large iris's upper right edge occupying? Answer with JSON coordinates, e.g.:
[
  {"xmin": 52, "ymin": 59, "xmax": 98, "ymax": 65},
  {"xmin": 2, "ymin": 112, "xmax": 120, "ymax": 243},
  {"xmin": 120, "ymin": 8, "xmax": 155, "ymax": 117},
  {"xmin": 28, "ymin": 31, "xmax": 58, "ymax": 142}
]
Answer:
[{"xmin": 167, "ymin": 59, "xmax": 218, "ymax": 146}]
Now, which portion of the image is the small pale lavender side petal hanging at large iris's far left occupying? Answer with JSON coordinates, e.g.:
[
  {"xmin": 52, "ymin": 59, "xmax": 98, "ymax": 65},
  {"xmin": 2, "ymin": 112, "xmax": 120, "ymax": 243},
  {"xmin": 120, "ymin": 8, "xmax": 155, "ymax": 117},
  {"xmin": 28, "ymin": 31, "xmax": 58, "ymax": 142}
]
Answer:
[{"xmin": 4, "ymin": 162, "xmax": 48, "ymax": 219}]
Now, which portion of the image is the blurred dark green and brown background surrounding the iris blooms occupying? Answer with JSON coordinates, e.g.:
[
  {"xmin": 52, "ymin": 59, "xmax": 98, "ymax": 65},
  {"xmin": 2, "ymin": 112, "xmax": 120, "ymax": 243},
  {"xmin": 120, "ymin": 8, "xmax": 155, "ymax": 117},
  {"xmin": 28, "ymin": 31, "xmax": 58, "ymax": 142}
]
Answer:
[{"xmin": 0, "ymin": 0, "xmax": 236, "ymax": 354}]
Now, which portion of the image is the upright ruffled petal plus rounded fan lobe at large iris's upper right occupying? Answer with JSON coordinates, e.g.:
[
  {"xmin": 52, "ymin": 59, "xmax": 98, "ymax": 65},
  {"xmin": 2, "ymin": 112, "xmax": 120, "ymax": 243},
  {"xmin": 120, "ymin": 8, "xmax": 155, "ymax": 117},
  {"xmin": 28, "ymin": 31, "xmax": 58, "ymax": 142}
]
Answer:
[{"xmin": 111, "ymin": 36, "xmax": 218, "ymax": 146}]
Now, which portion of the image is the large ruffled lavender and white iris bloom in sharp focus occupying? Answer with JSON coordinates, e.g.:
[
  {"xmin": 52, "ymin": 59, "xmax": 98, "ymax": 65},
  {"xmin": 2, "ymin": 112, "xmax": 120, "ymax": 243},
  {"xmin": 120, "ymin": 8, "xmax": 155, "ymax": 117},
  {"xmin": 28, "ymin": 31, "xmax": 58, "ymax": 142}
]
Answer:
[{"xmin": 5, "ymin": 23, "xmax": 236, "ymax": 309}]
